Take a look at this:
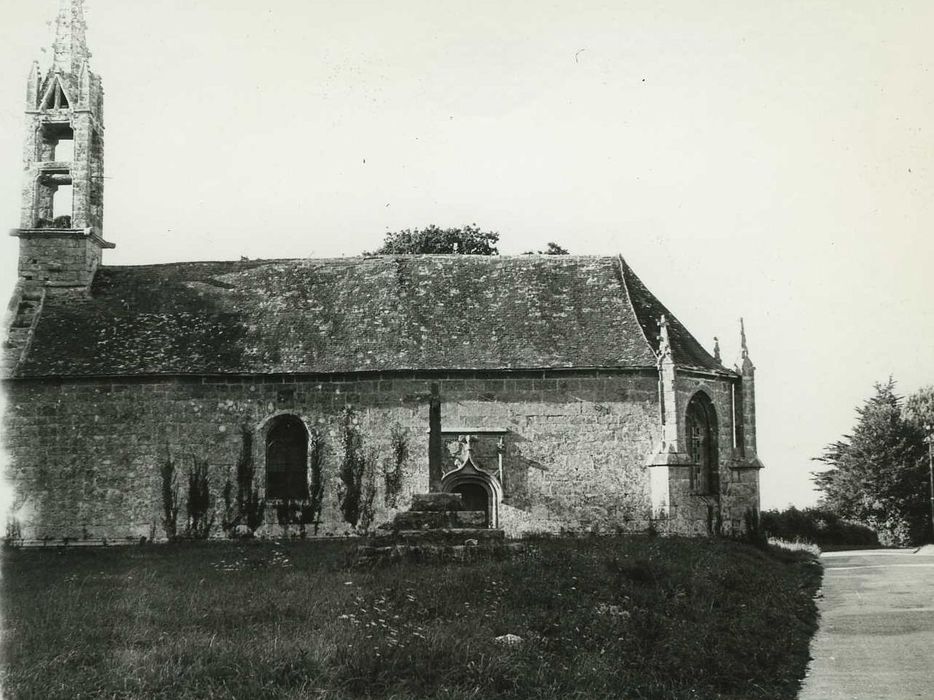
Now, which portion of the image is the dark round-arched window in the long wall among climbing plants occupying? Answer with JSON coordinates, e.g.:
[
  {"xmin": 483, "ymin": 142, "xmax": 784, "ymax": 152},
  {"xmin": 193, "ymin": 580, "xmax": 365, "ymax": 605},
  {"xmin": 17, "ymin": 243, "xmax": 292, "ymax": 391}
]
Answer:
[{"xmin": 266, "ymin": 416, "xmax": 308, "ymax": 500}]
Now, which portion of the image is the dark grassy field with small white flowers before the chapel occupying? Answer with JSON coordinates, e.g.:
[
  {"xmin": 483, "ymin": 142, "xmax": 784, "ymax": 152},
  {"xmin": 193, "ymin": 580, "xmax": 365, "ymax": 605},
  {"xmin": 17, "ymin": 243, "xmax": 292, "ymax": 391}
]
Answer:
[{"xmin": 0, "ymin": 537, "xmax": 820, "ymax": 700}]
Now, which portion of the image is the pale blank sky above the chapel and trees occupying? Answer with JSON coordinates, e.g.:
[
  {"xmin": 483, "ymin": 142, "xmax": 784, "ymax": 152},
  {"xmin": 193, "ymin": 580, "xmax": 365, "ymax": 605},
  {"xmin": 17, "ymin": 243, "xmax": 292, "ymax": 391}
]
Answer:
[{"xmin": 0, "ymin": 0, "xmax": 934, "ymax": 507}]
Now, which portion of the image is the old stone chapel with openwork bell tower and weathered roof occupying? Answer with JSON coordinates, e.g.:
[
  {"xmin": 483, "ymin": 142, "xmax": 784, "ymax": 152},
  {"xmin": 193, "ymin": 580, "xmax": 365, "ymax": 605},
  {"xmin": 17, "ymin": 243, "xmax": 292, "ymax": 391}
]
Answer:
[{"xmin": 2, "ymin": 0, "xmax": 762, "ymax": 543}]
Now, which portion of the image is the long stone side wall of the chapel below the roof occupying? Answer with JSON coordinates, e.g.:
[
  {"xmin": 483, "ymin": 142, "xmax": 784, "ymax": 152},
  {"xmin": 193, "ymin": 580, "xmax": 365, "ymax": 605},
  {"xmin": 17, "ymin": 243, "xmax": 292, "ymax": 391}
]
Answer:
[{"xmin": 3, "ymin": 372, "xmax": 659, "ymax": 542}]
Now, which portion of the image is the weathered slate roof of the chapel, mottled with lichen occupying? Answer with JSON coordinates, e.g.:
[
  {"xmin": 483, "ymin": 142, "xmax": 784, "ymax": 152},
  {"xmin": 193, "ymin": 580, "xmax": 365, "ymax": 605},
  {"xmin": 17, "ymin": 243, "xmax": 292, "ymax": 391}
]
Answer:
[{"xmin": 7, "ymin": 255, "xmax": 726, "ymax": 377}]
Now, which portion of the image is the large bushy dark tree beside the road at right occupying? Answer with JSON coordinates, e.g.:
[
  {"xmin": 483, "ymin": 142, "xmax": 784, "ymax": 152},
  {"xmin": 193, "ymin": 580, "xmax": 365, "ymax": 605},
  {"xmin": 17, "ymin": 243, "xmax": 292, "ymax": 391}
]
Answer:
[{"xmin": 813, "ymin": 379, "xmax": 929, "ymax": 545}]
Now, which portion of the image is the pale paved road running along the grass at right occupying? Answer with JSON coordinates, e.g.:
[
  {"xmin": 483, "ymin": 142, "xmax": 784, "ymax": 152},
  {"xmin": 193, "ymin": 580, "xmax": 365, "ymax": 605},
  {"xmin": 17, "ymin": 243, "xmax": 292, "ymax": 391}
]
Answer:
[{"xmin": 799, "ymin": 547, "xmax": 934, "ymax": 700}]
